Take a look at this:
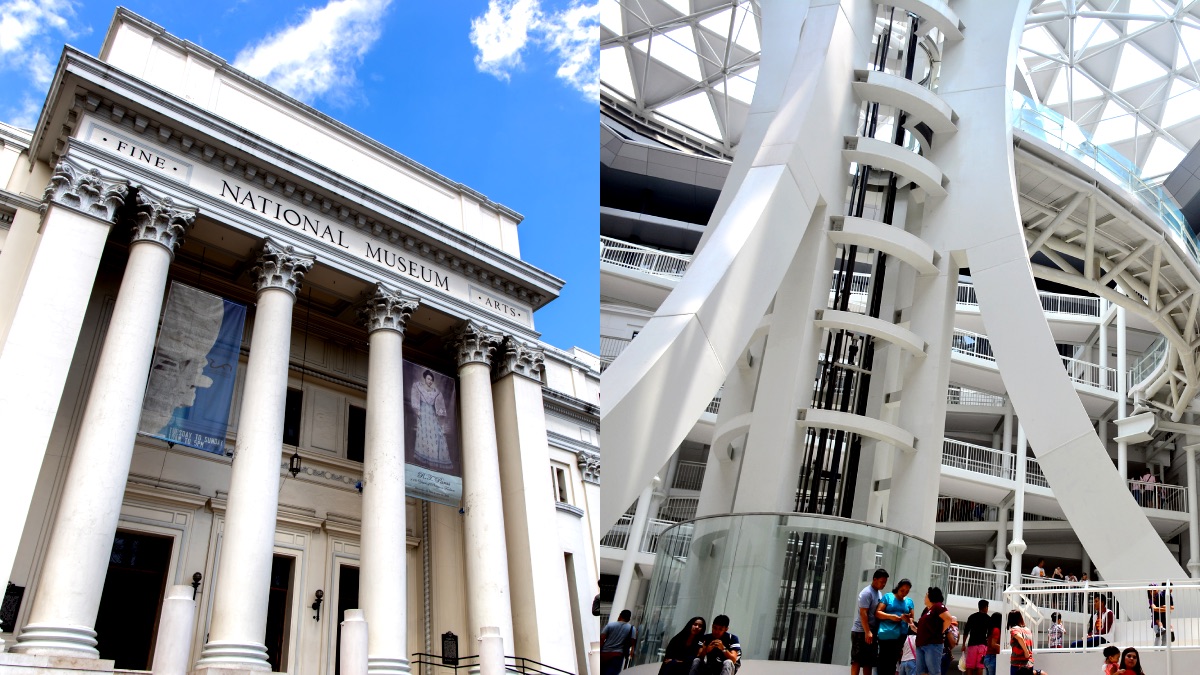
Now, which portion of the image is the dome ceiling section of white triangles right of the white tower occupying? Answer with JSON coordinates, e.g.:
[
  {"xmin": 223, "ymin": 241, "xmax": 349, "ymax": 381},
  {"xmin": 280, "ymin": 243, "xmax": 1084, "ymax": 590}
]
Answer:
[{"xmin": 1016, "ymin": 0, "xmax": 1200, "ymax": 180}]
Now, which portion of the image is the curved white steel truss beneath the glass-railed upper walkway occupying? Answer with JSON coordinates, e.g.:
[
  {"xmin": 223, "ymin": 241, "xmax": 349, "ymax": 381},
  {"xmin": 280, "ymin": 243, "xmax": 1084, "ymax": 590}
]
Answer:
[{"xmin": 1015, "ymin": 148, "xmax": 1200, "ymax": 422}]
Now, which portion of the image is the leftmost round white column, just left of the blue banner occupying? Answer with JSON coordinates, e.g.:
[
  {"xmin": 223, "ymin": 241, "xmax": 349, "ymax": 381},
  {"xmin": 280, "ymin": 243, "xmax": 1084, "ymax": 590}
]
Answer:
[{"xmin": 13, "ymin": 184, "xmax": 196, "ymax": 658}]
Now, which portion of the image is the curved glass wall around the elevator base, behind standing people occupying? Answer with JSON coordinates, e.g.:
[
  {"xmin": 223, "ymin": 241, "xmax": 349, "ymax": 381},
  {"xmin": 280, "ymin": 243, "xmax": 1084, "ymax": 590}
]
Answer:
[{"xmin": 635, "ymin": 513, "xmax": 949, "ymax": 664}]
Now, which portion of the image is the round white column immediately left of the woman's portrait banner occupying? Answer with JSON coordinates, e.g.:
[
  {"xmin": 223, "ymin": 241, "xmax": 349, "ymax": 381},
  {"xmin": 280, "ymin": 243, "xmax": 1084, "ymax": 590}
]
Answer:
[{"xmin": 359, "ymin": 286, "xmax": 418, "ymax": 675}]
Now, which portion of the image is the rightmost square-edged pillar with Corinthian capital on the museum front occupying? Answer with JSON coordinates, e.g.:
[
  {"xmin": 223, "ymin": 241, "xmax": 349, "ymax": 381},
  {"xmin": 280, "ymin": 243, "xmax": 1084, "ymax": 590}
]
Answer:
[{"xmin": 492, "ymin": 336, "xmax": 582, "ymax": 671}]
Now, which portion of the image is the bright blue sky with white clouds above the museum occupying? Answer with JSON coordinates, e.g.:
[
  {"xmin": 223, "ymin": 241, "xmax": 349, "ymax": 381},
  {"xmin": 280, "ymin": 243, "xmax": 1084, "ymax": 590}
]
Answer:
[{"xmin": 0, "ymin": 0, "xmax": 600, "ymax": 352}]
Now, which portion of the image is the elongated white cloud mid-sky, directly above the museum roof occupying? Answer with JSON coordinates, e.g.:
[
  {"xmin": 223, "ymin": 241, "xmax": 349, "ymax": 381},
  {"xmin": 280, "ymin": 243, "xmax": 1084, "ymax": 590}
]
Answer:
[{"xmin": 234, "ymin": 0, "xmax": 391, "ymax": 103}]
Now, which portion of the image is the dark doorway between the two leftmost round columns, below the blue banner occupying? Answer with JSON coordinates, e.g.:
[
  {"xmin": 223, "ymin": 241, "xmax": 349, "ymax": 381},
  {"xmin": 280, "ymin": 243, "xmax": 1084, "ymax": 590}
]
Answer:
[{"xmin": 96, "ymin": 530, "xmax": 174, "ymax": 670}]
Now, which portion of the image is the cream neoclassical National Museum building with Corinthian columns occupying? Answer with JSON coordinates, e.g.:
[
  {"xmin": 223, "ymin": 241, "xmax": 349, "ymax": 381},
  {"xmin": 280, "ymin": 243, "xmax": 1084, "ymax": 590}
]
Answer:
[{"xmin": 0, "ymin": 10, "xmax": 599, "ymax": 674}]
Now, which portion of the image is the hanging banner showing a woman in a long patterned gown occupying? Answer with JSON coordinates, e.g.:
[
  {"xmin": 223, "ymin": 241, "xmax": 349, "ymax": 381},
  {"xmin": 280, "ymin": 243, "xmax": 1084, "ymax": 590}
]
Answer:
[{"xmin": 404, "ymin": 360, "xmax": 462, "ymax": 507}]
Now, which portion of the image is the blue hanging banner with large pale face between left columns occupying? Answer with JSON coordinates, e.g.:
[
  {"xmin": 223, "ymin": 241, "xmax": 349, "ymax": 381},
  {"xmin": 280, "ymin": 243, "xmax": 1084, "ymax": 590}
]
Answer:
[{"xmin": 138, "ymin": 283, "xmax": 246, "ymax": 455}]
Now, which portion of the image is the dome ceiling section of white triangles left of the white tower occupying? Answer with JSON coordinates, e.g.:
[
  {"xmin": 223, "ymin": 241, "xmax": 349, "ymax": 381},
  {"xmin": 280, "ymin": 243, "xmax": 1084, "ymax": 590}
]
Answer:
[{"xmin": 600, "ymin": 0, "xmax": 762, "ymax": 156}]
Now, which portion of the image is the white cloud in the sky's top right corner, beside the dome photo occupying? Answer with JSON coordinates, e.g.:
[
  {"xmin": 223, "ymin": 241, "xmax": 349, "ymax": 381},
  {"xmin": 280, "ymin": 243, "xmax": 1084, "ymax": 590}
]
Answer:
[{"xmin": 470, "ymin": 0, "xmax": 600, "ymax": 98}]
